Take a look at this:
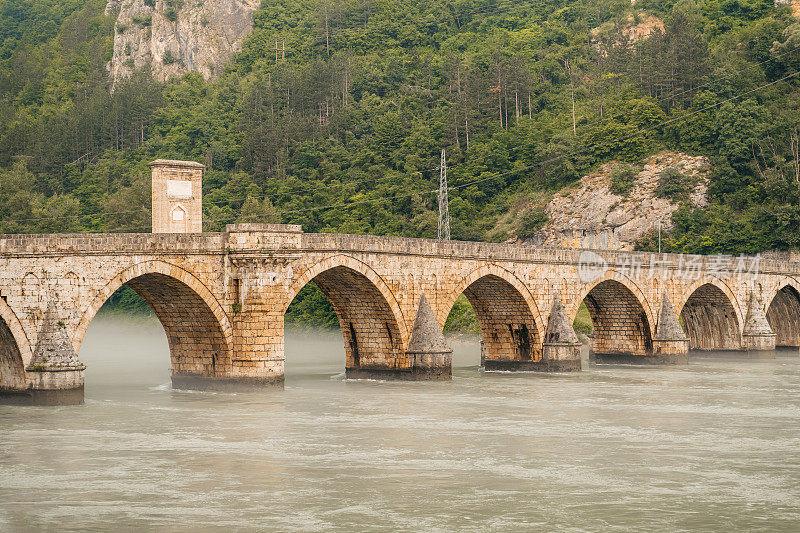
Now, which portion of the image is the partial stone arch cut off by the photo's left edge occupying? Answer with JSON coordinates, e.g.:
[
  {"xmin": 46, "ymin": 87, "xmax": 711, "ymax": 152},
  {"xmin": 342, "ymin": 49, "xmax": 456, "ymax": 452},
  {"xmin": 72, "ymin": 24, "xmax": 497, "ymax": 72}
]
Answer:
[{"xmin": 0, "ymin": 299, "xmax": 33, "ymax": 391}]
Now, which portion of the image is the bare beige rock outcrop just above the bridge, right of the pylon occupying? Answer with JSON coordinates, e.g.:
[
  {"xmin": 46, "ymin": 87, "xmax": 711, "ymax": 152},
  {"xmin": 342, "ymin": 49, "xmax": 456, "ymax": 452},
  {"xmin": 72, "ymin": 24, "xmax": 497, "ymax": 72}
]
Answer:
[{"xmin": 530, "ymin": 152, "xmax": 710, "ymax": 250}]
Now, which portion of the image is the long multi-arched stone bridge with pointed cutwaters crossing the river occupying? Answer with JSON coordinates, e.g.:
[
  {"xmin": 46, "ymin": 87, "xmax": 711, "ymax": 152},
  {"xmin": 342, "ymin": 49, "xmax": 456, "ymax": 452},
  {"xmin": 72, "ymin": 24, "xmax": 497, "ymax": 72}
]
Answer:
[{"xmin": 0, "ymin": 224, "xmax": 800, "ymax": 398}]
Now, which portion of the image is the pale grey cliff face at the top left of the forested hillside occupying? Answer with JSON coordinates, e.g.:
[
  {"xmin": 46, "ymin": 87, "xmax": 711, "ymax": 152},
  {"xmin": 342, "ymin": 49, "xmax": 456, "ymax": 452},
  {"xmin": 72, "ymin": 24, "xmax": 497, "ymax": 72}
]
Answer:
[{"xmin": 106, "ymin": 0, "xmax": 261, "ymax": 84}]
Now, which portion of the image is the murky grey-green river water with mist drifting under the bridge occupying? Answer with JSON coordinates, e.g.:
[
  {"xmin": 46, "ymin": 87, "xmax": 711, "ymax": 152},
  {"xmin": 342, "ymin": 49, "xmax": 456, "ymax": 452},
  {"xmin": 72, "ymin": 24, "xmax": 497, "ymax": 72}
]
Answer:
[{"xmin": 0, "ymin": 317, "xmax": 800, "ymax": 531}]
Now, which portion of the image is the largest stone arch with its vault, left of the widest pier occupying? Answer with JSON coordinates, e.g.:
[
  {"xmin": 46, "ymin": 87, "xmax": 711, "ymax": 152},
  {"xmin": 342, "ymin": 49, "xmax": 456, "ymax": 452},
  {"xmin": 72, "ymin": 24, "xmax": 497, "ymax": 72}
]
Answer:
[{"xmin": 73, "ymin": 260, "xmax": 233, "ymax": 377}]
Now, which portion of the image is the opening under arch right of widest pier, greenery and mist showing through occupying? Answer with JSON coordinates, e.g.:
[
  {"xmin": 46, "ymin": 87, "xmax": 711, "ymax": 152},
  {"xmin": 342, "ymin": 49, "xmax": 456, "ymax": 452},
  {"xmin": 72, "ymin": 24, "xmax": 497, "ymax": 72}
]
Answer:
[{"xmin": 284, "ymin": 266, "xmax": 408, "ymax": 376}]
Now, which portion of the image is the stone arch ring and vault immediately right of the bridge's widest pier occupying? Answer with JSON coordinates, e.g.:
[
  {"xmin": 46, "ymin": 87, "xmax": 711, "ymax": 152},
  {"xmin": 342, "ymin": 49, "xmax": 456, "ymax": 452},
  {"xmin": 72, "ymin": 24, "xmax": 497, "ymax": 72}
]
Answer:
[{"xmin": 282, "ymin": 254, "xmax": 409, "ymax": 368}]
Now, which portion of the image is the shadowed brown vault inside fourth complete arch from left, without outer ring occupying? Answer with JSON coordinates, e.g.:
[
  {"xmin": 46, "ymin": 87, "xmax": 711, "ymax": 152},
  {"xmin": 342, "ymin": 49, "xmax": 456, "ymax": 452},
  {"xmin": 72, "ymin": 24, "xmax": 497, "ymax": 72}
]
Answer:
[{"xmin": 578, "ymin": 280, "xmax": 653, "ymax": 356}]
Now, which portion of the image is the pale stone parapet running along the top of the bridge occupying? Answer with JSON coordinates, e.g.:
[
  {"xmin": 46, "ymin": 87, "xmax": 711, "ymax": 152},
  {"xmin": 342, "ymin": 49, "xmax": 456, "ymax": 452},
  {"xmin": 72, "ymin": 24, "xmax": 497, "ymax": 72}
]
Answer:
[{"xmin": 0, "ymin": 229, "xmax": 788, "ymax": 275}]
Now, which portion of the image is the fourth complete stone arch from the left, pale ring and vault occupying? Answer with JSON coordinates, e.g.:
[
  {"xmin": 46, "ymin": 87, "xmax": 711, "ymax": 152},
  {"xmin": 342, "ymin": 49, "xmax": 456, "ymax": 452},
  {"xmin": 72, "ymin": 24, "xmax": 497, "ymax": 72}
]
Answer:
[{"xmin": 567, "ymin": 270, "xmax": 656, "ymax": 356}]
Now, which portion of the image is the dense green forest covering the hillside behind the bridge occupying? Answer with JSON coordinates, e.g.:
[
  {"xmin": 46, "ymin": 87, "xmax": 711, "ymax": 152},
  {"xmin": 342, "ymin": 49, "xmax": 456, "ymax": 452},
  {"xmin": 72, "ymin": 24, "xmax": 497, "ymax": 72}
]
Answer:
[{"xmin": 0, "ymin": 0, "xmax": 800, "ymax": 253}]
